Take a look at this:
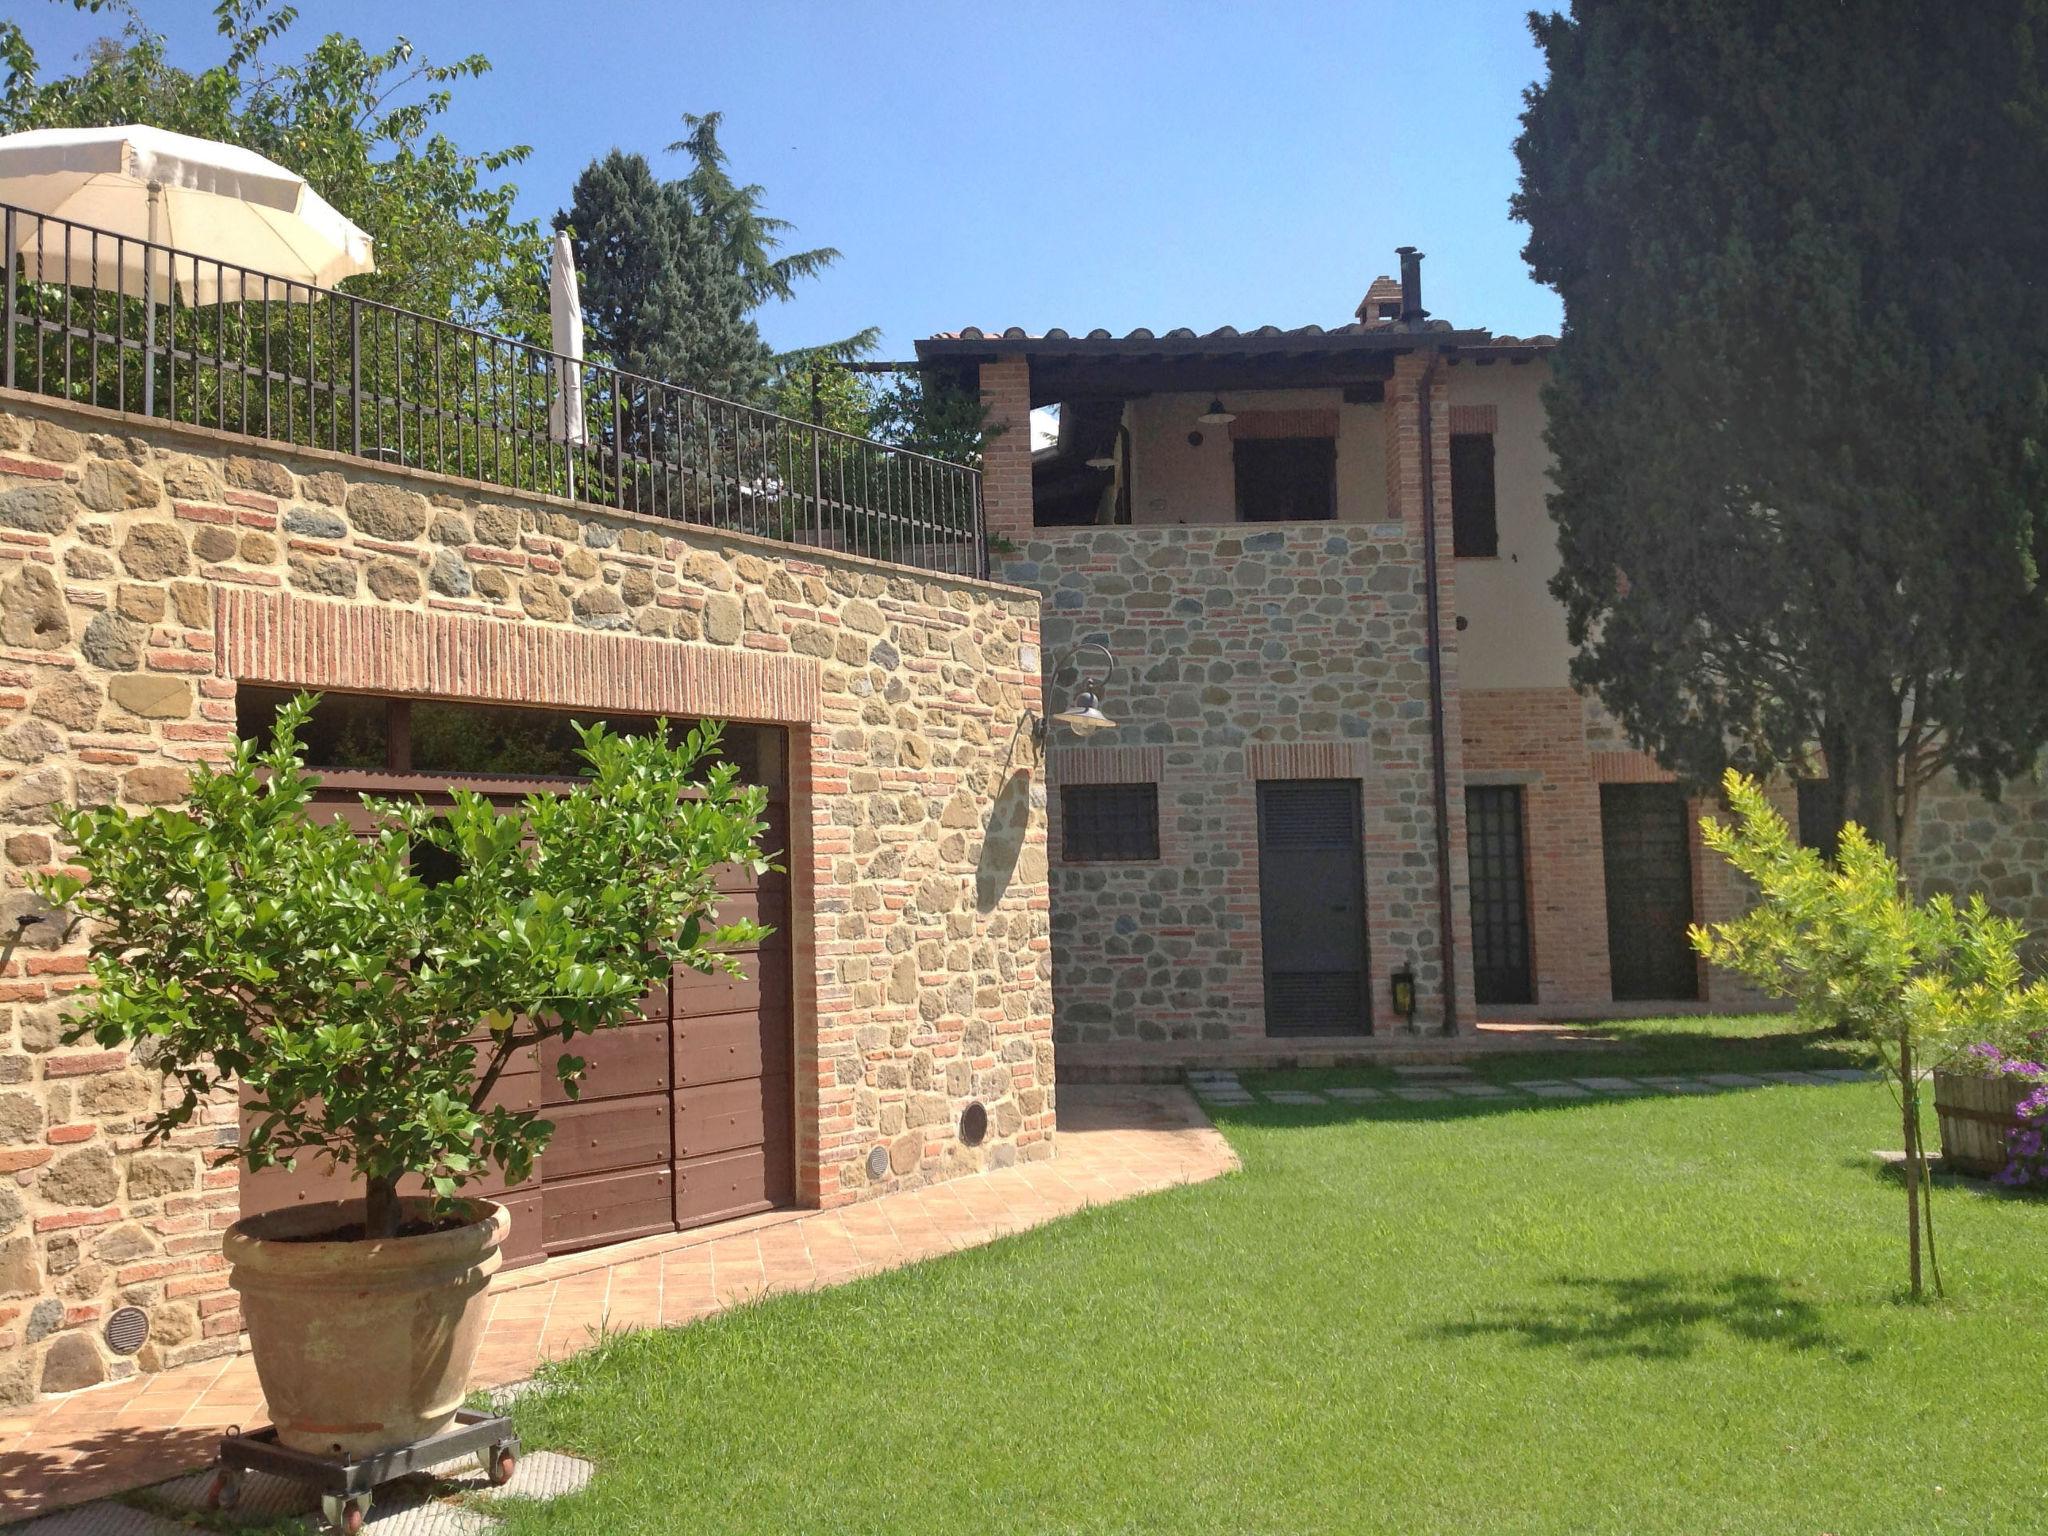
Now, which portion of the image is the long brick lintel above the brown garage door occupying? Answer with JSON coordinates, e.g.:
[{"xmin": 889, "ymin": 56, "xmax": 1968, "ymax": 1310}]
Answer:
[{"xmin": 213, "ymin": 588, "xmax": 819, "ymax": 725}]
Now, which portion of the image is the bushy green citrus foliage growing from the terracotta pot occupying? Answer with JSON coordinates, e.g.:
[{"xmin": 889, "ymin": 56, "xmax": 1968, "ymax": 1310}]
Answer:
[{"xmin": 35, "ymin": 696, "xmax": 766, "ymax": 1237}]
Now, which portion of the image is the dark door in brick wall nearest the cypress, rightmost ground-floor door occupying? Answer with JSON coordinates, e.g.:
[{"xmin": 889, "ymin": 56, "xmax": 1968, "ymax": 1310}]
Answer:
[{"xmin": 1599, "ymin": 784, "xmax": 1700, "ymax": 1001}]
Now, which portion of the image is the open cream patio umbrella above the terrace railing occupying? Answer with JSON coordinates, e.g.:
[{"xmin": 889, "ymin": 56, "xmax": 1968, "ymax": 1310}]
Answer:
[{"xmin": 0, "ymin": 123, "xmax": 377, "ymax": 412}]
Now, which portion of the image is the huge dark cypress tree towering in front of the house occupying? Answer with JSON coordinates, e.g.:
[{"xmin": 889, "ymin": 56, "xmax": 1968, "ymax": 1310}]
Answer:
[{"xmin": 1513, "ymin": 0, "xmax": 2048, "ymax": 850}]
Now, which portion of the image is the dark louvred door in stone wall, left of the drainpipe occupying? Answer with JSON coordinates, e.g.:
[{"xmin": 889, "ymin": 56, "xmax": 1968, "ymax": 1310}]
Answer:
[{"xmin": 1260, "ymin": 778, "xmax": 1372, "ymax": 1034}]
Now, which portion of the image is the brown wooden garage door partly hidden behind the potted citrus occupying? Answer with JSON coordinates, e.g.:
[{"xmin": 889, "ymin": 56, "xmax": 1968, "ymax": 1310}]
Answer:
[{"xmin": 242, "ymin": 690, "xmax": 795, "ymax": 1266}]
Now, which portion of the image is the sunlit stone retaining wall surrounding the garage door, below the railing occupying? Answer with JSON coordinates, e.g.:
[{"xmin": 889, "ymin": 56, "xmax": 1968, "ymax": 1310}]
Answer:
[{"xmin": 0, "ymin": 393, "xmax": 1055, "ymax": 1403}]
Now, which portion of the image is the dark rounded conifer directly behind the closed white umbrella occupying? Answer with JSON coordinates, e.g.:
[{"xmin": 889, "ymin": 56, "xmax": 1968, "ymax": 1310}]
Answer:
[{"xmin": 559, "ymin": 150, "xmax": 770, "ymax": 399}]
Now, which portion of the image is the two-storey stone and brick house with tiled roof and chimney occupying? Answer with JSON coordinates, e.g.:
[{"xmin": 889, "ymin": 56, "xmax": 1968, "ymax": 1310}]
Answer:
[{"xmin": 920, "ymin": 266, "xmax": 2048, "ymax": 1061}]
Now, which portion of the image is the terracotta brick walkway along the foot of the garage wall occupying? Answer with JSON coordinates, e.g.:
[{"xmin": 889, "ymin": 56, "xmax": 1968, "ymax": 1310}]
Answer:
[{"xmin": 0, "ymin": 1087, "xmax": 1237, "ymax": 1522}]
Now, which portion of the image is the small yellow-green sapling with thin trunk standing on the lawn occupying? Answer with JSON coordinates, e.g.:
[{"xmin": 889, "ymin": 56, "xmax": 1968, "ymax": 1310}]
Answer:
[{"xmin": 1692, "ymin": 768, "xmax": 2048, "ymax": 1296}]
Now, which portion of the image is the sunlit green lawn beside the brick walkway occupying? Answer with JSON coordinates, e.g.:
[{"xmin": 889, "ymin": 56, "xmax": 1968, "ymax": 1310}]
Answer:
[{"xmin": 499, "ymin": 1022, "xmax": 2048, "ymax": 1536}]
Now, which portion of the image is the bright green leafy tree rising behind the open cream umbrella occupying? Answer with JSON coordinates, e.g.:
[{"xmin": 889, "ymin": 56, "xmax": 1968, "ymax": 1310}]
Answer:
[{"xmin": 0, "ymin": 0, "xmax": 547, "ymax": 336}]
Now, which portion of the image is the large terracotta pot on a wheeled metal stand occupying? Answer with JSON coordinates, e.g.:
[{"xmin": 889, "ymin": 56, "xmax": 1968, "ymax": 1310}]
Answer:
[{"xmin": 221, "ymin": 1198, "xmax": 512, "ymax": 1456}]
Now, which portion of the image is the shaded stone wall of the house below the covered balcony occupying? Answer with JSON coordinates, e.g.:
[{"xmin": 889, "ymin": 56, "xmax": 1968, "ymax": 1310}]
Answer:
[{"xmin": 1001, "ymin": 522, "xmax": 1470, "ymax": 1042}]
